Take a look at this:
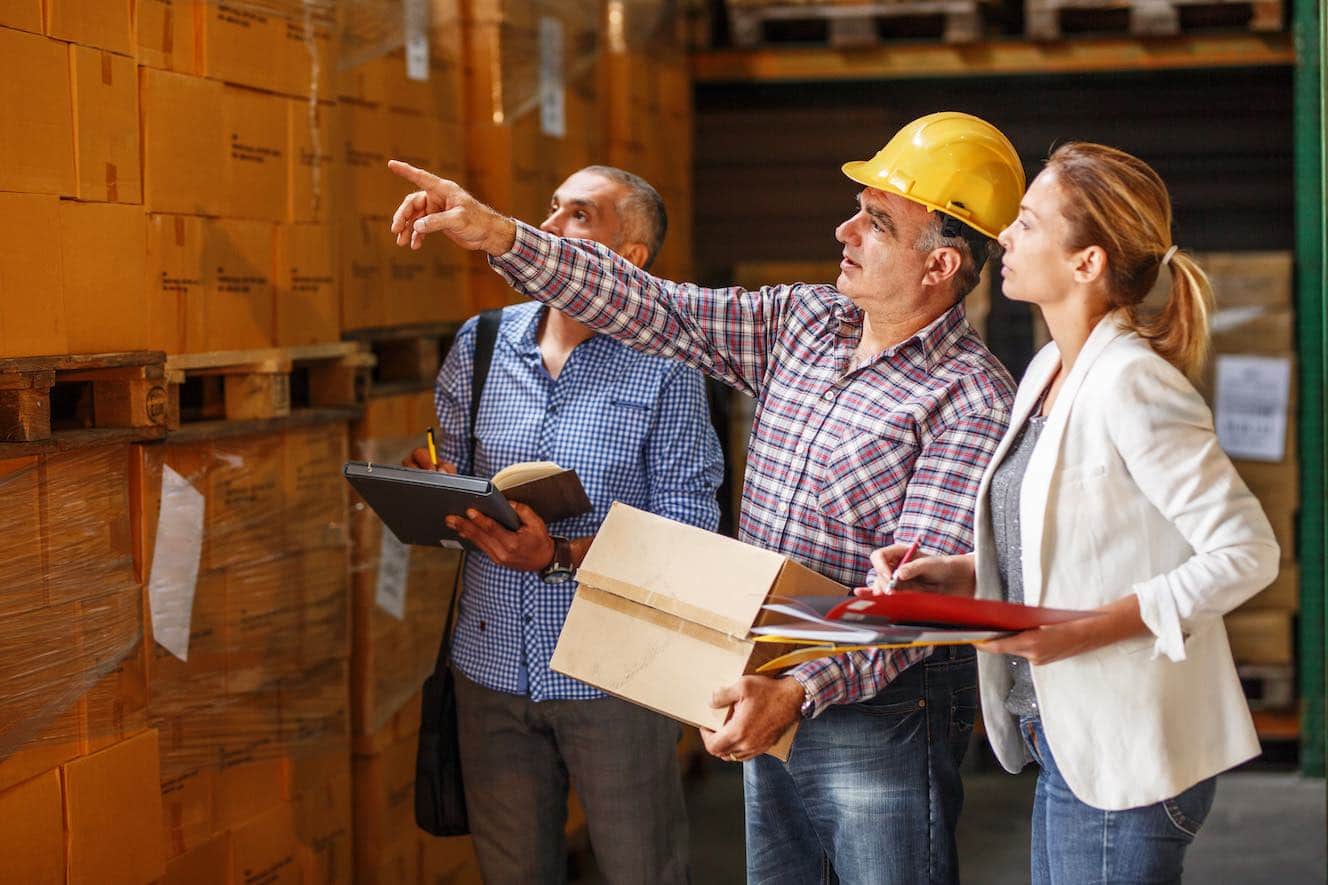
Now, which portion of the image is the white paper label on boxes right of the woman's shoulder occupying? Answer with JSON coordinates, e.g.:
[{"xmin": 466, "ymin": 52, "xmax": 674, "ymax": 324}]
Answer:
[{"xmin": 1214, "ymin": 355, "xmax": 1291, "ymax": 461}]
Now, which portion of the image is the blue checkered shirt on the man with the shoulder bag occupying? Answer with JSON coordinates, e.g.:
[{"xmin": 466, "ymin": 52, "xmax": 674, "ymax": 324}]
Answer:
[{"xmin": 434, "ymin": 303, "xmax": 724, "ymax": 700}]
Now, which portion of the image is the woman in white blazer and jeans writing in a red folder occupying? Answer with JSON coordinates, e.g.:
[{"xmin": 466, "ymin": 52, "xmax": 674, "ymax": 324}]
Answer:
[{"xmin": 872, "ymin": 144, "xmax": 1279, "ymax": 885}]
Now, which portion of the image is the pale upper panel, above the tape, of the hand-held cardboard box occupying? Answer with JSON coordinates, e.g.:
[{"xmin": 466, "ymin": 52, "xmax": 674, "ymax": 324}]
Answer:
[{"xmin": 576, "ymin": 502, "xmax": 786, "ymax": 638}]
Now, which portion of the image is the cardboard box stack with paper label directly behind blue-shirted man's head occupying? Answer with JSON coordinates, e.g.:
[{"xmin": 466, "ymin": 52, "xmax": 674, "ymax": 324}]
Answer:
[{"xmin": 463, "ymin": 0, "xmax": 603, "ymax": 311}]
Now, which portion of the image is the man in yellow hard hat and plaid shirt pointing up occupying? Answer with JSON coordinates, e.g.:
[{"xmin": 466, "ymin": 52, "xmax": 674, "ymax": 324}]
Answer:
[{"xmin": 392, "ymin": 112, "xmax": 1024, "ymax": 885}]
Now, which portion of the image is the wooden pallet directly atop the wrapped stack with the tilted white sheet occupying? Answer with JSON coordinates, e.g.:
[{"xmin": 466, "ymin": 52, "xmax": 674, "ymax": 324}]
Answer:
[{"xmin": 166, "ymin": 342, "xmax": 373, "ymax": 439}]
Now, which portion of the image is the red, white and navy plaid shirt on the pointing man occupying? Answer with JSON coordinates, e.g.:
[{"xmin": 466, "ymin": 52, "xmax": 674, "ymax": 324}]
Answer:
[{"xmin": 490, "ymin": 222, "xmax": 1015, "ymax": 716}]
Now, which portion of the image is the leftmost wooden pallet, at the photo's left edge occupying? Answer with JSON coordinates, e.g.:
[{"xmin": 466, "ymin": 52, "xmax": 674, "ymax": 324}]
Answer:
[{"xmin": 0, "ymin": 351, "xmax": 169, "ymax": 454}]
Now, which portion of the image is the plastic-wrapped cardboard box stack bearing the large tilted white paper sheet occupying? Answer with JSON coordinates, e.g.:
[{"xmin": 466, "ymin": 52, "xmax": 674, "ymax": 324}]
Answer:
[{"xmin": 133, "ymin": 421, "xmax": 352, "ymax": 884}]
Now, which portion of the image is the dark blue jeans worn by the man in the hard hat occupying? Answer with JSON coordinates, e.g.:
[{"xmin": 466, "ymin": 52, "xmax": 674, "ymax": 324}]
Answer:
[{"xmin": 742, "ymin": 646, "xmax": 977, "ymax": 885}]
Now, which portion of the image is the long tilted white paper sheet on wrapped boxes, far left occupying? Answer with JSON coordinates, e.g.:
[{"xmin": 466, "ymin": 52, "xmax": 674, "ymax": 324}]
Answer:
[{"xmin": 147, "ymin": 466, "xmax": 205, "ymax": 660}]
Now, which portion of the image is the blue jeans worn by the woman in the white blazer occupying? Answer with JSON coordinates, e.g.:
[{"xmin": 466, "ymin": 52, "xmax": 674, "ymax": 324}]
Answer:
[{"xmin": 1019, "ymin": 719, "xmax": 1218, "ymax": 885}]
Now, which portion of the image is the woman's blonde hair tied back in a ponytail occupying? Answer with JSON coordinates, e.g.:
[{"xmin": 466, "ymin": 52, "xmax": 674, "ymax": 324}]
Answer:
[{"xmin": 1046, "ymin": 142, "xmax": 1212, "ymax": 379}]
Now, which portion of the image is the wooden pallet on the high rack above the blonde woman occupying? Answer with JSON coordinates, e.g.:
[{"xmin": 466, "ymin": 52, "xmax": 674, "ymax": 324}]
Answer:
[{"xmin": 1024, "ymin": 0, "xmax": 1283, "ymax": 40}]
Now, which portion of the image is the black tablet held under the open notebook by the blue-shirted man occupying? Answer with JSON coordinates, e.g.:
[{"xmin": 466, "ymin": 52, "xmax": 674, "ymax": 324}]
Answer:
[{"xmin": 344, "ymin": 461, "xmax": 521, "ymax": 549}]
